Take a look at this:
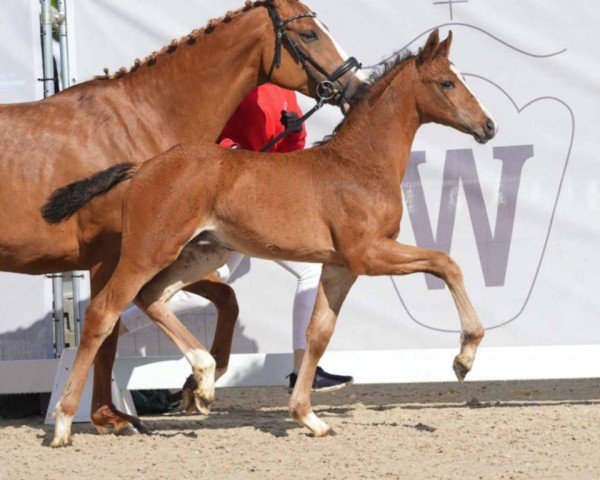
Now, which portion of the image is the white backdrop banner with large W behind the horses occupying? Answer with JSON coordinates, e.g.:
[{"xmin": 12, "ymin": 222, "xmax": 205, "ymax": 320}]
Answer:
[{"xmin": 57, "ymin": 0, "xmax": 600, "ymax": 370}]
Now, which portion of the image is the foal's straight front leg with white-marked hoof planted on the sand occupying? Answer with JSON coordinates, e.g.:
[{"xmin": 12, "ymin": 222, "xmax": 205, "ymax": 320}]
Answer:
[{"xmin": 290, "ymin": 265, "xmax": 356, "ymax": 437}]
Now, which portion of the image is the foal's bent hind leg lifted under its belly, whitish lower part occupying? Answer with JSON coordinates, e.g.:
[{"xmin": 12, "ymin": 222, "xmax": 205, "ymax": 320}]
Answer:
[{"xmin": 136, "ymin": 244, "xmax": 228, "ymax": 414}]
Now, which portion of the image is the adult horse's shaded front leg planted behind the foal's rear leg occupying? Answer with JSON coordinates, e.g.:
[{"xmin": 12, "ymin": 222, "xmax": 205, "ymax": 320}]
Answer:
[{"xmin": 91, "ymin": 262, "xmax": 148, "ymax": 434}]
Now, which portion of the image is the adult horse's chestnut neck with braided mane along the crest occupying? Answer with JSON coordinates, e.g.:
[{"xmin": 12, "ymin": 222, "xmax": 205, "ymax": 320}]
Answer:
[{"xmin": 116, "ymin": 8, "xmax": 269, "ymax": 148}]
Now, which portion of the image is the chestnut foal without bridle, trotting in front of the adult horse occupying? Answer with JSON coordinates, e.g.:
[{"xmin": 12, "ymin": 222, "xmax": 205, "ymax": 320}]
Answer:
[{"xmin": 45, "ymin": 30, "xmax": 496, "ymax": 446}]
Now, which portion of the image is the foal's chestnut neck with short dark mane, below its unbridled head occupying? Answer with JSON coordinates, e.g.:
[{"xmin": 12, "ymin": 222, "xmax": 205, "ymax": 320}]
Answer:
[{"xmin": 332, "ymin": 60, "xmax": 421, "ymax": 184}]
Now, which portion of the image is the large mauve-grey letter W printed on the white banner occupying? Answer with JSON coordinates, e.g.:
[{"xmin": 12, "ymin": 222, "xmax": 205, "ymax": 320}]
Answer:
[{"xmin": 402, "ymin": 145, "xmax": 533, "ymax": 289}]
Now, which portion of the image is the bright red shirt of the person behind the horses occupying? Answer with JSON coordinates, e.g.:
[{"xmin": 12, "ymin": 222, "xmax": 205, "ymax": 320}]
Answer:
[{"xmin": 218, "ymin": 83, "xmax": 306, "ymax": 153}]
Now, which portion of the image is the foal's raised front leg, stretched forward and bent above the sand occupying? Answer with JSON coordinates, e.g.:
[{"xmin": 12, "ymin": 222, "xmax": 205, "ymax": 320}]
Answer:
[{"xmin": 362, "ymin": 239, "xmax": 484, "ymax": 382}]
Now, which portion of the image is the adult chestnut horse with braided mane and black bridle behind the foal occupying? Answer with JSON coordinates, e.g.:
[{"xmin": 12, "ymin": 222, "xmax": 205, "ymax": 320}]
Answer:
[{"xmin": 0, "ymin": 0, "xmax": 359, "ymax": 438}]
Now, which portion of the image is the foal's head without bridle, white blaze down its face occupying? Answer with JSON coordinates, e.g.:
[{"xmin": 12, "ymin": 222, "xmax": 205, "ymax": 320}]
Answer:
[{"xmin": 415, "ymin": 30, "xmax": 497, "ymax": 143}]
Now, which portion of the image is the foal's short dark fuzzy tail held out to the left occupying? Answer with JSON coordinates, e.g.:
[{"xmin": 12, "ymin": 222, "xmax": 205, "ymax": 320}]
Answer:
[{"xmin": 42, "ymin": 163, "xmax": 137, "ymax": 224}]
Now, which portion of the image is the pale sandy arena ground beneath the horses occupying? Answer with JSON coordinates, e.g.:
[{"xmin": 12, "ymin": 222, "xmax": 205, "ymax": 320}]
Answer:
[{"xmin": 0, "ymin": 380, "xmax": 600, "ymax": 480}]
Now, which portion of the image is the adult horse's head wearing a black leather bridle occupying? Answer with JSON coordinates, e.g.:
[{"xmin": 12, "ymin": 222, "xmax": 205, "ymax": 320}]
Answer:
[{"xmin": 262, "ymin": 0, "xmax": 364, "ymax": 105}]
